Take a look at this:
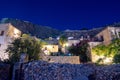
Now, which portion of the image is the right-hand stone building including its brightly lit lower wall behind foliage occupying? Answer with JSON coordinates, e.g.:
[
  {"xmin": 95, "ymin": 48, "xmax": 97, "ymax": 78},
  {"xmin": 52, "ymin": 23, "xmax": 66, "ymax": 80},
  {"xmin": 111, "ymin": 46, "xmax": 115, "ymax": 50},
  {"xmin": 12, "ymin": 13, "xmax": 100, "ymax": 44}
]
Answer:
[{"xmin": 91, "ymin": 26, "xmax": 120, "ymax": 63}]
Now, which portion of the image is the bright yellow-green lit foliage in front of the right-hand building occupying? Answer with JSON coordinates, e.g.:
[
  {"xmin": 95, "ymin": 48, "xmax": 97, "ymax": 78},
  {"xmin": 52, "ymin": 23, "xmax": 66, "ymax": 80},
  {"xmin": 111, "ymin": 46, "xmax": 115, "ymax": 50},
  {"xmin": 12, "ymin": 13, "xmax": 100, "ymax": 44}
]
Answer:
[{"xmin": 92, "ymin": 39, "xmax": 120, "ymax": 63}]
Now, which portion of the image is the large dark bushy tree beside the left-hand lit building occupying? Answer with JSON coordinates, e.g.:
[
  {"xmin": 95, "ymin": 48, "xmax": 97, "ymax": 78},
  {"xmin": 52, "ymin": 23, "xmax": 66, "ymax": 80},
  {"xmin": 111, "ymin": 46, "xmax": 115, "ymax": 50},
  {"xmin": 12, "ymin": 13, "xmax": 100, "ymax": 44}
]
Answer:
[{"xmin": 6, "ymin": 34, "xmax": 41, "ymax": 63}]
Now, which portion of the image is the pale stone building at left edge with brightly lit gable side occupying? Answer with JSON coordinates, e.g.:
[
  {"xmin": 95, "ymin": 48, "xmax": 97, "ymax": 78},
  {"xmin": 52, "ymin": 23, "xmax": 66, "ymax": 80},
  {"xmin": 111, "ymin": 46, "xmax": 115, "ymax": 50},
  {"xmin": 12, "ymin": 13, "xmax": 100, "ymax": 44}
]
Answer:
[{"xmin": 0, "ymin": 23, "xmax": 21, "ymax": 60}]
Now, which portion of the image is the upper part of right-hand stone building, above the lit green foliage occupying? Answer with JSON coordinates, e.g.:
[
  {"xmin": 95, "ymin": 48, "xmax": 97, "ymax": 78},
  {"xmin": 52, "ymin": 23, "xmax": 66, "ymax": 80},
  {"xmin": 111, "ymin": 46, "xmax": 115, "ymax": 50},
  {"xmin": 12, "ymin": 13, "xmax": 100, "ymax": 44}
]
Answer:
[{"xmin": 95, "ymin": 26, "xmax": 120, "ymax": 45}]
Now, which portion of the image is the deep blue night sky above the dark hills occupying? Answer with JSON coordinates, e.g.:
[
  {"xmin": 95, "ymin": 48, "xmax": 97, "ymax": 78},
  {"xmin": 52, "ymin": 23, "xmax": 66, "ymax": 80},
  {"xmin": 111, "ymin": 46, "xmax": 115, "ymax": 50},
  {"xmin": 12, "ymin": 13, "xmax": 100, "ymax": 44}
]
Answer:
[{"xmin": 0, "ymin": 0, "xmax": 120, "ymax": 30}]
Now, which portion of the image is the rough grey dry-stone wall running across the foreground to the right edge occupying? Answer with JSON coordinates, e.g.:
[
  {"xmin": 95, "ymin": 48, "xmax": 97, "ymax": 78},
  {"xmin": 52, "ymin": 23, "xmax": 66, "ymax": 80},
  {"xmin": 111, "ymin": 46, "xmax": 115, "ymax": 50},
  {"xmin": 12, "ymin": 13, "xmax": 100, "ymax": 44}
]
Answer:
[{"xmin": 23, "ymin": 61, "xmax": 120, "ymax": 80}]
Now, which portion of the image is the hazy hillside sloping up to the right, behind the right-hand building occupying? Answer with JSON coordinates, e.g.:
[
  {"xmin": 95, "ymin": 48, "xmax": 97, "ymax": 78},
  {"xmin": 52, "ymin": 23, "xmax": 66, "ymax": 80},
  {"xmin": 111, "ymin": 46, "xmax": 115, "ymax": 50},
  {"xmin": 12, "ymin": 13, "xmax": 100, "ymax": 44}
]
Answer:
[{"xmin": 62, "ymin": 22, "xmax": 120, "ymax": 39}]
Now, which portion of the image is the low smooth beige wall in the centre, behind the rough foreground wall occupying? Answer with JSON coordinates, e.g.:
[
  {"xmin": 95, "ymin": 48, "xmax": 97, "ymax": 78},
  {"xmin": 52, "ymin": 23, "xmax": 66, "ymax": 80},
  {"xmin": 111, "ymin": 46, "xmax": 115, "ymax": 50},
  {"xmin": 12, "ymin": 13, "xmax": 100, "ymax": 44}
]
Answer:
[{"xmin": 43, "ymin": 56, "xmax": 80, "ymax": 64}]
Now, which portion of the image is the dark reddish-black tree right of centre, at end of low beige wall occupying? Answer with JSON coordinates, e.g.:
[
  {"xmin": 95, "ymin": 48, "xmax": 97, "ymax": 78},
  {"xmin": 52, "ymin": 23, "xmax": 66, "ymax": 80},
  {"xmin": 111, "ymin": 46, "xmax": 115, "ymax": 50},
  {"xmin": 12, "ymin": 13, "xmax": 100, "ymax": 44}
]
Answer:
[{"xmin": 68, "ymin": 40, "xmax": 90, "ymax": 62}]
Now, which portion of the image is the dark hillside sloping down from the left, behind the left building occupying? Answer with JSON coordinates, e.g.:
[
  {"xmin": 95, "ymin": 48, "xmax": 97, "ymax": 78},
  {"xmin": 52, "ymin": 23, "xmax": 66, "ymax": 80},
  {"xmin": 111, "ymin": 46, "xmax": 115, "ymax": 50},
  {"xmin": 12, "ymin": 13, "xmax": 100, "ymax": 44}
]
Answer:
[{"xmin": 0, "ymin": 18, "xmax": 60, "ymax": 39}]
